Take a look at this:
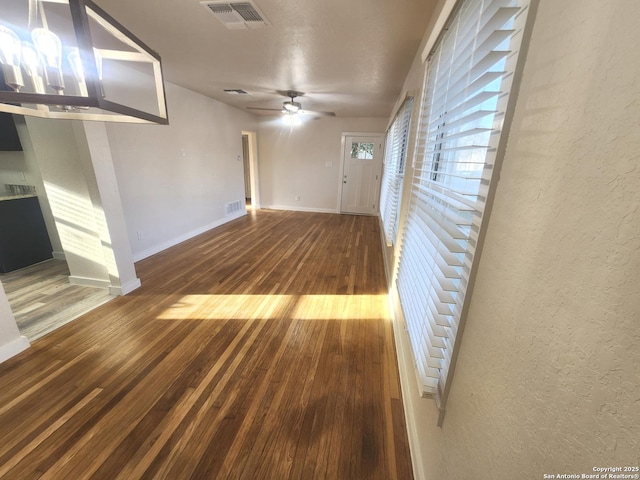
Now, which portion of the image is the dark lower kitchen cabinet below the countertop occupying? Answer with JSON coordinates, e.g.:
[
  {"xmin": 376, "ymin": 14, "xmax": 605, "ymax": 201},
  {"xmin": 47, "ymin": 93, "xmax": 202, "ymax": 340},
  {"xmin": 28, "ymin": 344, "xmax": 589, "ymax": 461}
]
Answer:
[{"xmin": 0, "ymin": 197, "xmax": 52, "ymax": 273}]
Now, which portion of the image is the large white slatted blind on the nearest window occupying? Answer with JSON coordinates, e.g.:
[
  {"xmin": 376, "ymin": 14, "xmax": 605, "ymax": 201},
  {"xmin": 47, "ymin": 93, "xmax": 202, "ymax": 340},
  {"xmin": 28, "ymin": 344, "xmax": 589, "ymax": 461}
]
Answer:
[{"xmin": 397, "ymin": 0, "xmax": 528, "ymax": 396}]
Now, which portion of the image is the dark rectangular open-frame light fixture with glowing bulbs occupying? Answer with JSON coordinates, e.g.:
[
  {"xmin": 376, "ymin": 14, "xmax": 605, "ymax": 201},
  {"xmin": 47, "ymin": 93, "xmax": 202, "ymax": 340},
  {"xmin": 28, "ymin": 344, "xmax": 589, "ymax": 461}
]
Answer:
[{"xmin": 0, "ymin": 0, "xmax": 168, "ymax": 124}]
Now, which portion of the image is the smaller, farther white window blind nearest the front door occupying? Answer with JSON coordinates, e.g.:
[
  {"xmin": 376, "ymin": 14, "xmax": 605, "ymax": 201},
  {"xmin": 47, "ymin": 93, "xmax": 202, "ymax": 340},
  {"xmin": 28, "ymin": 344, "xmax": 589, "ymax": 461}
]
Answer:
[{"xmin": 380, "ymin": 97, "xmax": 413, "ymax": 245}]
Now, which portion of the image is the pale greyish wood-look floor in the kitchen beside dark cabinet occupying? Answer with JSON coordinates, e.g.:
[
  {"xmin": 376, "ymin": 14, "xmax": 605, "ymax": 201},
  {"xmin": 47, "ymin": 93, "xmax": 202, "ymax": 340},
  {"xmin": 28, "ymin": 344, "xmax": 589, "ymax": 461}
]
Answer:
[{"xmin": 0, "ymin": 260, "xmax": 115, "ymax": 341}]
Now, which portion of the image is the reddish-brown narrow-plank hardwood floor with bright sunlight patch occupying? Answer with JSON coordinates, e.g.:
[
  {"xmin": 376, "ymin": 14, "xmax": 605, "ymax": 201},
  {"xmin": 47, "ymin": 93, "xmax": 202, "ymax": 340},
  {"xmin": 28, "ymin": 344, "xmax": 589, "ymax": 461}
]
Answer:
[{"xmin": 0, "ymin": 210, "xmax": 412, "ymax": 480}]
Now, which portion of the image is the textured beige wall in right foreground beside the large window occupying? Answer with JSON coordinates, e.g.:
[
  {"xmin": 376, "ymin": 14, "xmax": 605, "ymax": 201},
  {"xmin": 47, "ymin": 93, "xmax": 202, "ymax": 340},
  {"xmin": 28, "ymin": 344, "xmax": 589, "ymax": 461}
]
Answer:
[{"xmin": 390, "ymin": 0, "xmax": 640, "ymax": 480}]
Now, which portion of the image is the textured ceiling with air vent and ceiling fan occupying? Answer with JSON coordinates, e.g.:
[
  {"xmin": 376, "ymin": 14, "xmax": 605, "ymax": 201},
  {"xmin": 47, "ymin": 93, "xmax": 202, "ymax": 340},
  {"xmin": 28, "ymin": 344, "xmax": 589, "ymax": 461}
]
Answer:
[{"xmin": 95, "ymin": 0, "xmax": 437, "ymax": 117}]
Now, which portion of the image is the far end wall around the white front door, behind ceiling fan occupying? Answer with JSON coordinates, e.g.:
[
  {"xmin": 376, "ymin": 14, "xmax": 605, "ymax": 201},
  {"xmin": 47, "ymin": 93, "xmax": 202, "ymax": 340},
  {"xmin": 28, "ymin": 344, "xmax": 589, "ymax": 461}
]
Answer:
[{"xmin": 258, "ymin": 117, "xmax": 387, "ymax": 212}]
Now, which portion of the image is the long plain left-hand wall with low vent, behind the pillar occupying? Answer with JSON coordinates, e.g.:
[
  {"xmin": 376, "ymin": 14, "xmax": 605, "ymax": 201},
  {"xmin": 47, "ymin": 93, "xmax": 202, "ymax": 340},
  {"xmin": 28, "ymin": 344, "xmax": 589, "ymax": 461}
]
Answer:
[{"xmin": 107, "ymin": 83, "xmax": 257, "ymax": 260}]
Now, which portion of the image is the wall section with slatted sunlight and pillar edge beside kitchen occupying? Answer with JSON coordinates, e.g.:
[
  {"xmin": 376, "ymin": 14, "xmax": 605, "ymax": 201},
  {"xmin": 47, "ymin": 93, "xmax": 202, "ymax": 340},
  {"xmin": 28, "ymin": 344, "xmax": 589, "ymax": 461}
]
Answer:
[{"xmin": 19, "ymin": 117, "xmax": 140, "ymax": 295}]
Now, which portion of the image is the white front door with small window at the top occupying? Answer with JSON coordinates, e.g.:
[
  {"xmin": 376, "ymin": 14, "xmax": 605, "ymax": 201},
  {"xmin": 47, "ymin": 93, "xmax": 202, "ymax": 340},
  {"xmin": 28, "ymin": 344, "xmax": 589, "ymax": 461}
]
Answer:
[{"xmin": 340, "ymin": 135, "xmax": 382, "ymax": 215}]
